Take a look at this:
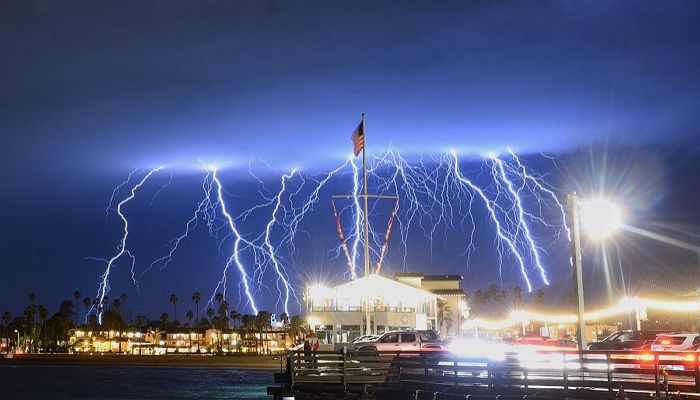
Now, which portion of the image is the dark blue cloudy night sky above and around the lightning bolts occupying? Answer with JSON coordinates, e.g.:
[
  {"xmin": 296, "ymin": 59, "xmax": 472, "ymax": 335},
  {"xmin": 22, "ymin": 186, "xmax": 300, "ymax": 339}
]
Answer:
[{"xmin": 0, "ymin": 0, "xmax": 700, "ymax": 317}]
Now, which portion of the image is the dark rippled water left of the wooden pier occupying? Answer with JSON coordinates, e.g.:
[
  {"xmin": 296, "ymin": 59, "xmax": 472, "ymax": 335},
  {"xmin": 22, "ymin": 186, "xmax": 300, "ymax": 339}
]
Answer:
[{"xmin": 0, "ymin": 365, "xmax": 273, "ymax": 400}]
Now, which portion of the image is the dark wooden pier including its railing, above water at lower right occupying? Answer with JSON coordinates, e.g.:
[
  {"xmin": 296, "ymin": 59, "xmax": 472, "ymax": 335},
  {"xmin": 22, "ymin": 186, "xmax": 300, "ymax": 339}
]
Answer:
[{"xmin": 268, "ymin": 350, "xmax": 700, "ymax": 400}]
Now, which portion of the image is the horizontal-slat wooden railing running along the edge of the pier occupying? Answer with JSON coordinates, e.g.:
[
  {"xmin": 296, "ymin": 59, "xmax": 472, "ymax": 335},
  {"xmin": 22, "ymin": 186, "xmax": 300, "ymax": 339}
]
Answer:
[{"xmin": 285, "ymin": 350, "xmax": 700, "ymax": 396}]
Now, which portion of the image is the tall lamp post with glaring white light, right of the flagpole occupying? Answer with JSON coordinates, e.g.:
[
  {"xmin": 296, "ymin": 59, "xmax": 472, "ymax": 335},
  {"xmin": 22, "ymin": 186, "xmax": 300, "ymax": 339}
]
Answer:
[{"xmin": 567, "ymin": 192, "xmax": 622, "ymax": 350}]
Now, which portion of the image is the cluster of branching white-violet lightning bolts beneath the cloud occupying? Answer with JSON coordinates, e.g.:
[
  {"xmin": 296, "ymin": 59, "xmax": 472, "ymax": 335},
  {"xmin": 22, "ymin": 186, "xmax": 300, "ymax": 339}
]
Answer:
[{"xmin": 89, "ymin": 149, "xmax": 569, "ymax": 315}]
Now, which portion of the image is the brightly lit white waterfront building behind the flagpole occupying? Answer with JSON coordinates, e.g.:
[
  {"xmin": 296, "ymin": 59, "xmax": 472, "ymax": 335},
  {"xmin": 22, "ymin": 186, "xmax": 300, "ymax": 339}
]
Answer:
[{"xmin": 304, "ymin": 273, "xmax": 467, "ymax": 343}]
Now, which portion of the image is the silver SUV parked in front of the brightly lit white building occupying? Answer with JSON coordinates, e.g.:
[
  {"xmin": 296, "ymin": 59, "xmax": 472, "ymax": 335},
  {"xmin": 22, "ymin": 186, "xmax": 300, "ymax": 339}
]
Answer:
[{"xmin": 357, "ymin": 330, "xmax": 447, "ymax": 351}]
